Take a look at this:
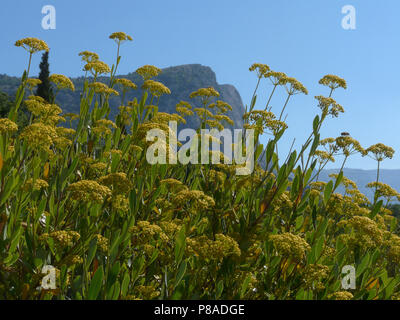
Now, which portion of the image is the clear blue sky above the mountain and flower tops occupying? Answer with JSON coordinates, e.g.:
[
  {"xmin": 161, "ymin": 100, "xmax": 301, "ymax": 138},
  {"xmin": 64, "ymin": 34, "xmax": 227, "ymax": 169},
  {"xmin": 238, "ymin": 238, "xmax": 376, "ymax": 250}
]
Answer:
[{"xmin": 0, "ymin": 0, "xmax": 400, "ymax": 169}]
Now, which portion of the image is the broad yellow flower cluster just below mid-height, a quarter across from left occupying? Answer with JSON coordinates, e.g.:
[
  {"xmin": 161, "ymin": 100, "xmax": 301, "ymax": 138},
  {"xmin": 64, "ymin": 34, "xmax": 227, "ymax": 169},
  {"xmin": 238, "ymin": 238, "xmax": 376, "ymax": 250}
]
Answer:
[{"xmin": 67, "ymin": 180, "xmax": 111, "ymax": 203}]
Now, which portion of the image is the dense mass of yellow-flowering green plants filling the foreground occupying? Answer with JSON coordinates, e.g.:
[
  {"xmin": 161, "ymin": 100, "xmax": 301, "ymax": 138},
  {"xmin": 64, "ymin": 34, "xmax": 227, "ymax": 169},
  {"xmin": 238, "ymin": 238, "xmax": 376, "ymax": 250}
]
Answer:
[{"xmin": 0, "ymin": 32, "xmax": 400, "ymax": 300}]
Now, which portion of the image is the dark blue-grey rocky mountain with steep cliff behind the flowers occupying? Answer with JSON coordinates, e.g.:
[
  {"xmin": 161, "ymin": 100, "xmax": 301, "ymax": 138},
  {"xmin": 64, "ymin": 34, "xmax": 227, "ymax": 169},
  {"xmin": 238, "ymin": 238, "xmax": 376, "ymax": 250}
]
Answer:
[{"xmin": 0, "ymin": 64, "xmax": 244, "ymax": 128}]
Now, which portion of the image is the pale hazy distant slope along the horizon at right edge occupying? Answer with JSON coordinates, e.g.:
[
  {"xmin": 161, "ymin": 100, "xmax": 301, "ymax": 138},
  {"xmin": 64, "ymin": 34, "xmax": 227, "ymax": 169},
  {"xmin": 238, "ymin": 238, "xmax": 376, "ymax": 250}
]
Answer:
[{"xmin": 319, "ymin": 168, "xmax": 400, "ymax": 200}]
